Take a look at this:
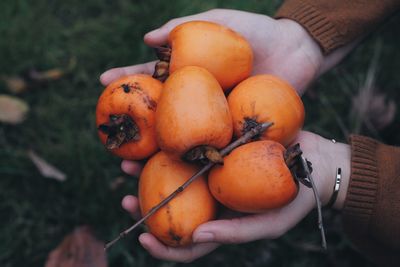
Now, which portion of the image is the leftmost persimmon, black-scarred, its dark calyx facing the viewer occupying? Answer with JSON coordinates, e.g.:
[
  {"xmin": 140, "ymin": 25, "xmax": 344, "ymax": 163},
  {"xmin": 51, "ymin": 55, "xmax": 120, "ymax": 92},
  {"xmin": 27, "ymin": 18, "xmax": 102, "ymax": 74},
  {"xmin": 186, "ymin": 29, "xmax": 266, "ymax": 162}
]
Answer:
[{"xmin": 96, "ymin": 74, "xmax": 162, "ymax": 160}]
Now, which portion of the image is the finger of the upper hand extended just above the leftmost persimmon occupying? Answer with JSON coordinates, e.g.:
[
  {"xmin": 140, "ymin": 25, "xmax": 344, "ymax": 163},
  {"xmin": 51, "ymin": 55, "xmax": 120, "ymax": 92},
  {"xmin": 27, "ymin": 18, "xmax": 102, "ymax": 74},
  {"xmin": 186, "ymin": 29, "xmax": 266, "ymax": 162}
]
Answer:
[{"xmin": 100, "ymin": 61, "xmax": 156, "ymax": 86}]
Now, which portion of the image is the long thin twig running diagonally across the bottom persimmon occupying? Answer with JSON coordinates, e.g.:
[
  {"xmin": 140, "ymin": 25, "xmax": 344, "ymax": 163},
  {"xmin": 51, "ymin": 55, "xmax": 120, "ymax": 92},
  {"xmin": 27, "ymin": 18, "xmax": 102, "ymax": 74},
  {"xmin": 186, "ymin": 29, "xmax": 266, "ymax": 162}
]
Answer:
[{"xmin": 104, "ymin": 122, "xmax": 273, "ymax": 250}]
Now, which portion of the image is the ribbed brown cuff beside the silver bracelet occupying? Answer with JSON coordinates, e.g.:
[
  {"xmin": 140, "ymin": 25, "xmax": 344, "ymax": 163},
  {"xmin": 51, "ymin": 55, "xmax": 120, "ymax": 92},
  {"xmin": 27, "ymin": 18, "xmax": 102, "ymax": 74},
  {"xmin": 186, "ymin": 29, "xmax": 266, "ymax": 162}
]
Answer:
[{"xmin": 343, "ymin": 135, "xmax": 379, "ymax": 232}]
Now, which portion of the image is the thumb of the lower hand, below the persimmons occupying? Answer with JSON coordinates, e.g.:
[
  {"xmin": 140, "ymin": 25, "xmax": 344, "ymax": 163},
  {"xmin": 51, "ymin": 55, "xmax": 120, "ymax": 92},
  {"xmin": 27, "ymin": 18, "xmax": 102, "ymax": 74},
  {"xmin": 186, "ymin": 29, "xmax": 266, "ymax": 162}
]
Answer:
[{"xmin": 193, "ymin": 185, "xmax": 314, "ymax": 244}]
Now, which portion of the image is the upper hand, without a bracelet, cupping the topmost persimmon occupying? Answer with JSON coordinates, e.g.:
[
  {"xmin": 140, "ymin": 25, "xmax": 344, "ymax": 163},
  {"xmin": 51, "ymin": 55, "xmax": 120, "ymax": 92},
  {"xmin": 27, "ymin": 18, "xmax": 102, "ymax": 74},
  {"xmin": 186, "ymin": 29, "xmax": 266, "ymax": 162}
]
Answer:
[{"xmin": 100, "ymin": 9, "xmax": 353, "ymax": 94}]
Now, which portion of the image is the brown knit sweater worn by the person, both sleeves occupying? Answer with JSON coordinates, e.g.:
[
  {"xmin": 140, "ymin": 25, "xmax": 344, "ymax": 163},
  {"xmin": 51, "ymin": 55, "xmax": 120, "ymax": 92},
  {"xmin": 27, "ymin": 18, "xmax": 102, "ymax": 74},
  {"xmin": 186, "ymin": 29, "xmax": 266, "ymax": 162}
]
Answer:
[{"xmin": 276, "ymin": 0, "xmax": 400, "ymax": 266}]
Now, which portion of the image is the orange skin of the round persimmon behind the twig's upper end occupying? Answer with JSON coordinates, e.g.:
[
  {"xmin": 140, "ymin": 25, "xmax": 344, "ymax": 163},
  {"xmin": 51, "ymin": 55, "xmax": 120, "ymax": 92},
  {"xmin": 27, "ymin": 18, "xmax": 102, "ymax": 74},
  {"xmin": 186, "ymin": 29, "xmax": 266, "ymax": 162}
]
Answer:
[{"xmin": 228, "ymin": 75, "xmax": 304, "ymax": 146}]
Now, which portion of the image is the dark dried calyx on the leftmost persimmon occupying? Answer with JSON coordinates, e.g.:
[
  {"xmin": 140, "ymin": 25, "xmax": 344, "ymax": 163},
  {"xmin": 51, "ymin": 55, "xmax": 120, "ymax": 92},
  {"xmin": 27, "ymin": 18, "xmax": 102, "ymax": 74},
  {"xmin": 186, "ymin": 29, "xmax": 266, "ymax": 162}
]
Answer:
[{"xmin": 98, "ymin": 114, "xmax": 140, "ymax": 149}]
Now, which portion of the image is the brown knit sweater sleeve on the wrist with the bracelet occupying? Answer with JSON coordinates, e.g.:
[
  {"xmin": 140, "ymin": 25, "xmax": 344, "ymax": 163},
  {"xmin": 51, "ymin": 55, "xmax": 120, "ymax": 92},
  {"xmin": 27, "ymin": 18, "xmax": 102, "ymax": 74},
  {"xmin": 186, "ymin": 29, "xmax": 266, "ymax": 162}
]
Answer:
[{"xmin": 343, "ymin": 136, "xmax": 400, "ymax": 266}]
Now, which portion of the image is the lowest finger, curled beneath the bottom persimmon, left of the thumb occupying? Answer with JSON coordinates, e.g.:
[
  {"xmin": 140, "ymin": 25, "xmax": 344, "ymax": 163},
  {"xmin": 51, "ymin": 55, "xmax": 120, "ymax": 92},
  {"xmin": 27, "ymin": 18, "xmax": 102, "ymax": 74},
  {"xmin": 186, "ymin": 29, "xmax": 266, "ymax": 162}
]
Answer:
[{"xmin": 139, "ymin": 233, "xmax": 219, "ymax": 263}]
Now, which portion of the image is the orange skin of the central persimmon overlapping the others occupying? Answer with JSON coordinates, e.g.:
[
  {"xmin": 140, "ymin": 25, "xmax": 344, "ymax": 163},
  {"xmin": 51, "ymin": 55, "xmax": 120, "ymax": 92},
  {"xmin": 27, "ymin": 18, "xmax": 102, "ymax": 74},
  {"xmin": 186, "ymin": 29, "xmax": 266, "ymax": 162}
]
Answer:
[{"xmin": 156, "ymin": 66, "xmax": 233, "ymax": 160}]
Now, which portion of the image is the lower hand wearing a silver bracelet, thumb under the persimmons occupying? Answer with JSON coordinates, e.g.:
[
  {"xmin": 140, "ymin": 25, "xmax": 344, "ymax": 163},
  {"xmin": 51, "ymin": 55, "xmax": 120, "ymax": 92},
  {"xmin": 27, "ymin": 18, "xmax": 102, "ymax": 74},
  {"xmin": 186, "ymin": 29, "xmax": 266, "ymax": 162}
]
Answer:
[{"xmin": 122, "ymin": 132, "xmax": 350, "ymax": 262}]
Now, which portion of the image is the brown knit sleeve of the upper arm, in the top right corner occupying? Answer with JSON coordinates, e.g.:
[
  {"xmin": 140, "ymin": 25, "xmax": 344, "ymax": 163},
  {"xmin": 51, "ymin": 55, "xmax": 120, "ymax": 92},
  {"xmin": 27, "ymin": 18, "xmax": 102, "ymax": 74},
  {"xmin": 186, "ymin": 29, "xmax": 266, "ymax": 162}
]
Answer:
[{"xmin": 275, "ymin": 0, "xmax": 400, "ymax": 54}]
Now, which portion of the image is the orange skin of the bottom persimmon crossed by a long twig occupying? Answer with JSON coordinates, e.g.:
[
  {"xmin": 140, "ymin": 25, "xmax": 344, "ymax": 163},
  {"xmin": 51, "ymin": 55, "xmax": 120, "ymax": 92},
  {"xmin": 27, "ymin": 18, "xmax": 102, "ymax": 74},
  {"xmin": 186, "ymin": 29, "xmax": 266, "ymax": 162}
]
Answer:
[{"xmin": 139, "ymin": 151, "xmax": 216, "ymax": 247}]
